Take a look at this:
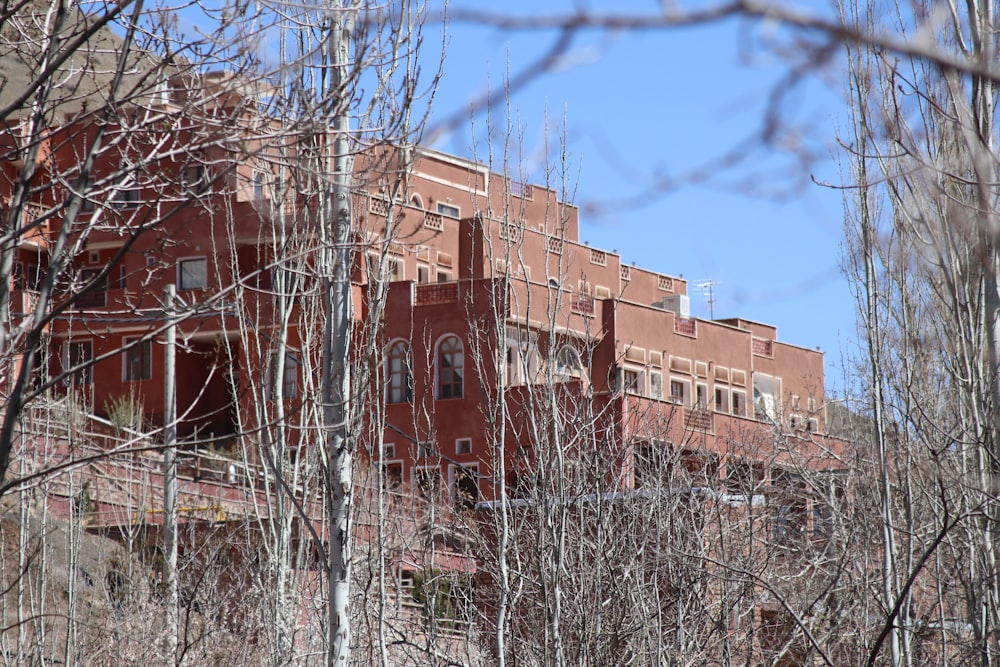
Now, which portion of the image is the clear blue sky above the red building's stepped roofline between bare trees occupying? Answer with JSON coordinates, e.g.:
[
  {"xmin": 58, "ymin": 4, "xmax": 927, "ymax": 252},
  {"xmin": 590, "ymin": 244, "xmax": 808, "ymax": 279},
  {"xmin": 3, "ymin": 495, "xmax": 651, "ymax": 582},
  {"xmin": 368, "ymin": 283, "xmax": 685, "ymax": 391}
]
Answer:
[{"xmin": 427, "ymin": 0, "xmax": 855, "ymax": 387}]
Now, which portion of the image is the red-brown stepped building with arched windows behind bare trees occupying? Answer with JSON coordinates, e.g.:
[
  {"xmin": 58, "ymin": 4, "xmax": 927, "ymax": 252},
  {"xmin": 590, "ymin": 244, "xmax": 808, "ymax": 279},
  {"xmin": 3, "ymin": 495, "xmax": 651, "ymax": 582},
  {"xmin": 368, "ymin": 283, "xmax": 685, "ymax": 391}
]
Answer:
[{"xmin": 4, "ymin": 81, "xmax": 840, "ymax": 516}]
